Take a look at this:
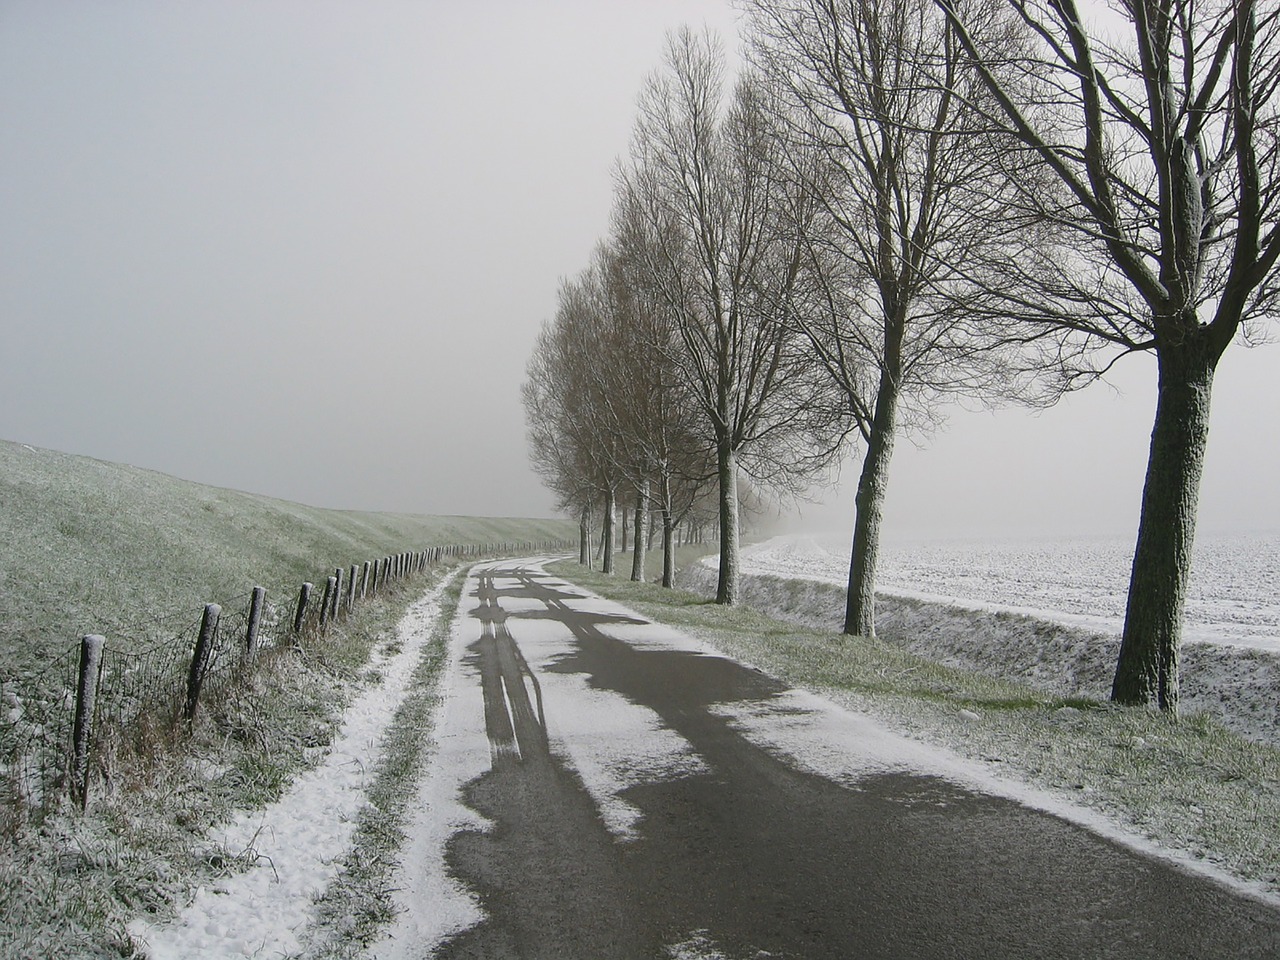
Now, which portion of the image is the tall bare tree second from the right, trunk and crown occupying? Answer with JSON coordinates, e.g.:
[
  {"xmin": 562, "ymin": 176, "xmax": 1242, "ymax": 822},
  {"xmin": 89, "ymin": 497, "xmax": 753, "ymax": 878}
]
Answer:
[{"xmin": 746, "ymin": 0, "xmax": 1054, "ymax": 636}]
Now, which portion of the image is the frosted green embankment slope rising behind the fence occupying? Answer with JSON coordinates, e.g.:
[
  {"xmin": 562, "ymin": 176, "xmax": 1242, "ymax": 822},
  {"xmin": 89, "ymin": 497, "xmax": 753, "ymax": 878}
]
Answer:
[{"xmin": 0, "ymin": 440, "xmax": 577, "ymax": 686}]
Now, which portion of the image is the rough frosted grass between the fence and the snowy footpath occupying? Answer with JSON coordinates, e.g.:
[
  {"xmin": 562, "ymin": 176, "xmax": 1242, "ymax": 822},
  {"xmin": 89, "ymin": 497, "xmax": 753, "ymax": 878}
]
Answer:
[{"xmin": 0, "ymin": 573, "xmax": 438, "ymax": 957}]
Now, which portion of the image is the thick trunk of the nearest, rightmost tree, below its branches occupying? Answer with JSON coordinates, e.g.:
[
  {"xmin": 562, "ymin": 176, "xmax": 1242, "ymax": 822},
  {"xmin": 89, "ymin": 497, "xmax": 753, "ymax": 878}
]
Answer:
[{"xmin": 1111, "ymin": 334, "xmax": 1220, "ymax": 716}]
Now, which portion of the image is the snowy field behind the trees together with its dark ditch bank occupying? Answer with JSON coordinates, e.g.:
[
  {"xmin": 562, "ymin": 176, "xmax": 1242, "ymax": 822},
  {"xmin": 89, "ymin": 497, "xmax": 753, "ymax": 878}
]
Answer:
[{"xmin": 711, "ymin": 536, "xmax": 1280, "ymax": 745}]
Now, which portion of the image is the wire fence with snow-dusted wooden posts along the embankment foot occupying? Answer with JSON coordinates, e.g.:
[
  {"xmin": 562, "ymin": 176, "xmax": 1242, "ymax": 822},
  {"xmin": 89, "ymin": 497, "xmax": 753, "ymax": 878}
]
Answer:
[{"xmin": 0, "ymin": 540, "xmax": 572, "ymax": 819}]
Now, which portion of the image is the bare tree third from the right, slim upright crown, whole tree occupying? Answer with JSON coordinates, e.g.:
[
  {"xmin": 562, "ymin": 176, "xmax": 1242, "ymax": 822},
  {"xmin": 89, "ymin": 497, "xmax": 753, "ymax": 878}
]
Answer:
[{"xmin": 621, "ymin": 29, "xmax": 840, "ymax": 603}]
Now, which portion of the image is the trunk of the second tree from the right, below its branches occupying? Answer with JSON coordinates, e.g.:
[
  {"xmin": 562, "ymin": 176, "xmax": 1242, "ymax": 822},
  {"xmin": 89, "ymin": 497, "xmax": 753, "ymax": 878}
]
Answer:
[{"xmin": 845, "ymin": 370, "xmax": 899, "ymax": 636}]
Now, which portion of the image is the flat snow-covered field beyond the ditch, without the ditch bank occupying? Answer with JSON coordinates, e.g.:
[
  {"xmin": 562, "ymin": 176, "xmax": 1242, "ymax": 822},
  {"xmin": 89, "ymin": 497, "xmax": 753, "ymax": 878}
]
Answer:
[{"xmin": 742, "ymin": 534, "xmax": 1280, "ymax": 652}]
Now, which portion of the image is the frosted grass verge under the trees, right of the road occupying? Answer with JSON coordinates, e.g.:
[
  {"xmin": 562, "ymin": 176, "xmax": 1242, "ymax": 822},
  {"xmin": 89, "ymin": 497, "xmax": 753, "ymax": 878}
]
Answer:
[{"xmin": 550, "ymin": 562, "xmax": 1280, "ymax": 892}]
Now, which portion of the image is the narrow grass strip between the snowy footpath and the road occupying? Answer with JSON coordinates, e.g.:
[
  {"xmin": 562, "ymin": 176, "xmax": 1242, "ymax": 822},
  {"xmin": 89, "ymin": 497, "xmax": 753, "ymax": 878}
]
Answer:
[{"xmin": 303, "ymin": 573, "xmax": 463, "ymax": 960}]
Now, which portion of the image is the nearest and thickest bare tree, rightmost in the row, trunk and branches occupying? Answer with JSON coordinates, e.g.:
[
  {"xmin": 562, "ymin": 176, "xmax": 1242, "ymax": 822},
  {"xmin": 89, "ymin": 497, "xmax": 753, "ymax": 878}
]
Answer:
[{"xmin": 936, "ymin": 0, "xmax": 1280, "ymax": 713}]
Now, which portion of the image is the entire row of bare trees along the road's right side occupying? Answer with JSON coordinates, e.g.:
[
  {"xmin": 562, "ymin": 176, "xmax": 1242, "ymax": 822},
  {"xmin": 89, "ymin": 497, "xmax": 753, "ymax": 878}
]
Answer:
[{"xmin": 525, "ymin": 0, "xmax": 1280, "ymax": 713}]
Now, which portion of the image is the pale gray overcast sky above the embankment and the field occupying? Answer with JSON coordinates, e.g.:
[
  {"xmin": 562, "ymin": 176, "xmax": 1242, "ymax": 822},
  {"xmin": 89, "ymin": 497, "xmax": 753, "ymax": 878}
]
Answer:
[{"xmin": 0, "ymin": 0, "xmax": 1280, "ymax": 535}]
